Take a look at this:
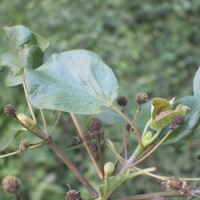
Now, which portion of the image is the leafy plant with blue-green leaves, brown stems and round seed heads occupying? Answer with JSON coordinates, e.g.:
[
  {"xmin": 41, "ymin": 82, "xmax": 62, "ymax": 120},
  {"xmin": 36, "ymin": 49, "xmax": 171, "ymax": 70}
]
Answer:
[{"xmin": 0, "ymin": 25, "xmax": 200, "ymax": 200}]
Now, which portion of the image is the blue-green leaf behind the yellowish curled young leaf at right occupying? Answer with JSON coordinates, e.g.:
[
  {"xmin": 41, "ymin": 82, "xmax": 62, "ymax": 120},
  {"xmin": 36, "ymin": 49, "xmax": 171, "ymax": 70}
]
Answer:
[{"xmin": 164, "ymin": 96, "xmax": 200, "ymax": 144}]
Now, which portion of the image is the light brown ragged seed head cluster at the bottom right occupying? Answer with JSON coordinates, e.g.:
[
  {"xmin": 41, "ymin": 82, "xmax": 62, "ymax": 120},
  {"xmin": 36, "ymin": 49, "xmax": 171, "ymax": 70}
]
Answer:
[{"xmin": 162, "ymin": 176, "xmax": 191, "ymax": 195}]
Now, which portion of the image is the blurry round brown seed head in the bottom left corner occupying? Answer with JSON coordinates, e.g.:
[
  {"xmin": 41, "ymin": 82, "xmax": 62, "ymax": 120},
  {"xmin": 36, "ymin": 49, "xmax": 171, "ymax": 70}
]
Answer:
[{"xmin": 2, "ymin": 176, "xmax": 21, "ymax": 194}]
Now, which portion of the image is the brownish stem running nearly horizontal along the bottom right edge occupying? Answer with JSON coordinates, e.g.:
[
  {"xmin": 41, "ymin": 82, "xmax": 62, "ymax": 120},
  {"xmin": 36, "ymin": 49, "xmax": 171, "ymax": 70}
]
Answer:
[{"xmin": 113, "ymin": 191, "xmax": 183, "ymax": 200}]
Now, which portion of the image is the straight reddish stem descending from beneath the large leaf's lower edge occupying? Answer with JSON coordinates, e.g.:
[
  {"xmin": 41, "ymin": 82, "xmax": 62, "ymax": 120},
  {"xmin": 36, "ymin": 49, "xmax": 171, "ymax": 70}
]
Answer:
[{"xmin": 70, "ymin": 113, "xmax": 103, "ymax": 180}]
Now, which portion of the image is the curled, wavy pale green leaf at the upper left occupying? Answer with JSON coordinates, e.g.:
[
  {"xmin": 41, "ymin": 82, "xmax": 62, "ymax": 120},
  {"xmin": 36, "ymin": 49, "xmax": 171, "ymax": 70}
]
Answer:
[{"xmin": 0, "ymin": 25, "xmax": 49, "ymax": 86}]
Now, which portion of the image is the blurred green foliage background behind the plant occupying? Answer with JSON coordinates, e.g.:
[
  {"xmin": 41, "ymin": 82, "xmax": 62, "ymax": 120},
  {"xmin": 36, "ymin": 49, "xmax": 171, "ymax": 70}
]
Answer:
[{"xmin": 0, "ymin": 0, "xmax": 200, "ymax": 200}]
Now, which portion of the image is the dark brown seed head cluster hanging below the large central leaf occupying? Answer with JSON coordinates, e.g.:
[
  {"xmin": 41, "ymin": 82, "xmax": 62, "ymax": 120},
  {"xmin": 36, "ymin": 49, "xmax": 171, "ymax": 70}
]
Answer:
[{"xmin": 84, "ymin": 118, "xmax": 104, "ymax": 152}]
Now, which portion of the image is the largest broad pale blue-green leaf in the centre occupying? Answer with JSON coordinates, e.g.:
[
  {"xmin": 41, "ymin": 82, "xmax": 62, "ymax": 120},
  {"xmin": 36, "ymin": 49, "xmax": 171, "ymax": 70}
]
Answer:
[{"xmin": 25, "ymin": 50, "xmax": 118, "ymax": 114}]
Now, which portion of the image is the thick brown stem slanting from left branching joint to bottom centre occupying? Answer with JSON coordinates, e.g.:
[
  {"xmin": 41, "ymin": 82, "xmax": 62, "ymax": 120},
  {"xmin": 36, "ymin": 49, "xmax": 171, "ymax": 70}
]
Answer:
[{"xmin": 49, "ymin": 137, "xmax": 98, "ymax": 197}]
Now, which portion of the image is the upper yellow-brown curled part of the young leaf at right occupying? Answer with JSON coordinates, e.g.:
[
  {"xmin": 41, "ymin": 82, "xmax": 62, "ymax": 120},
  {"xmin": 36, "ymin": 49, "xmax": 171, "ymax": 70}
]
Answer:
[{"xmin": 151, "ymin": 98, "xmax": 170, "ymax": 120}]
